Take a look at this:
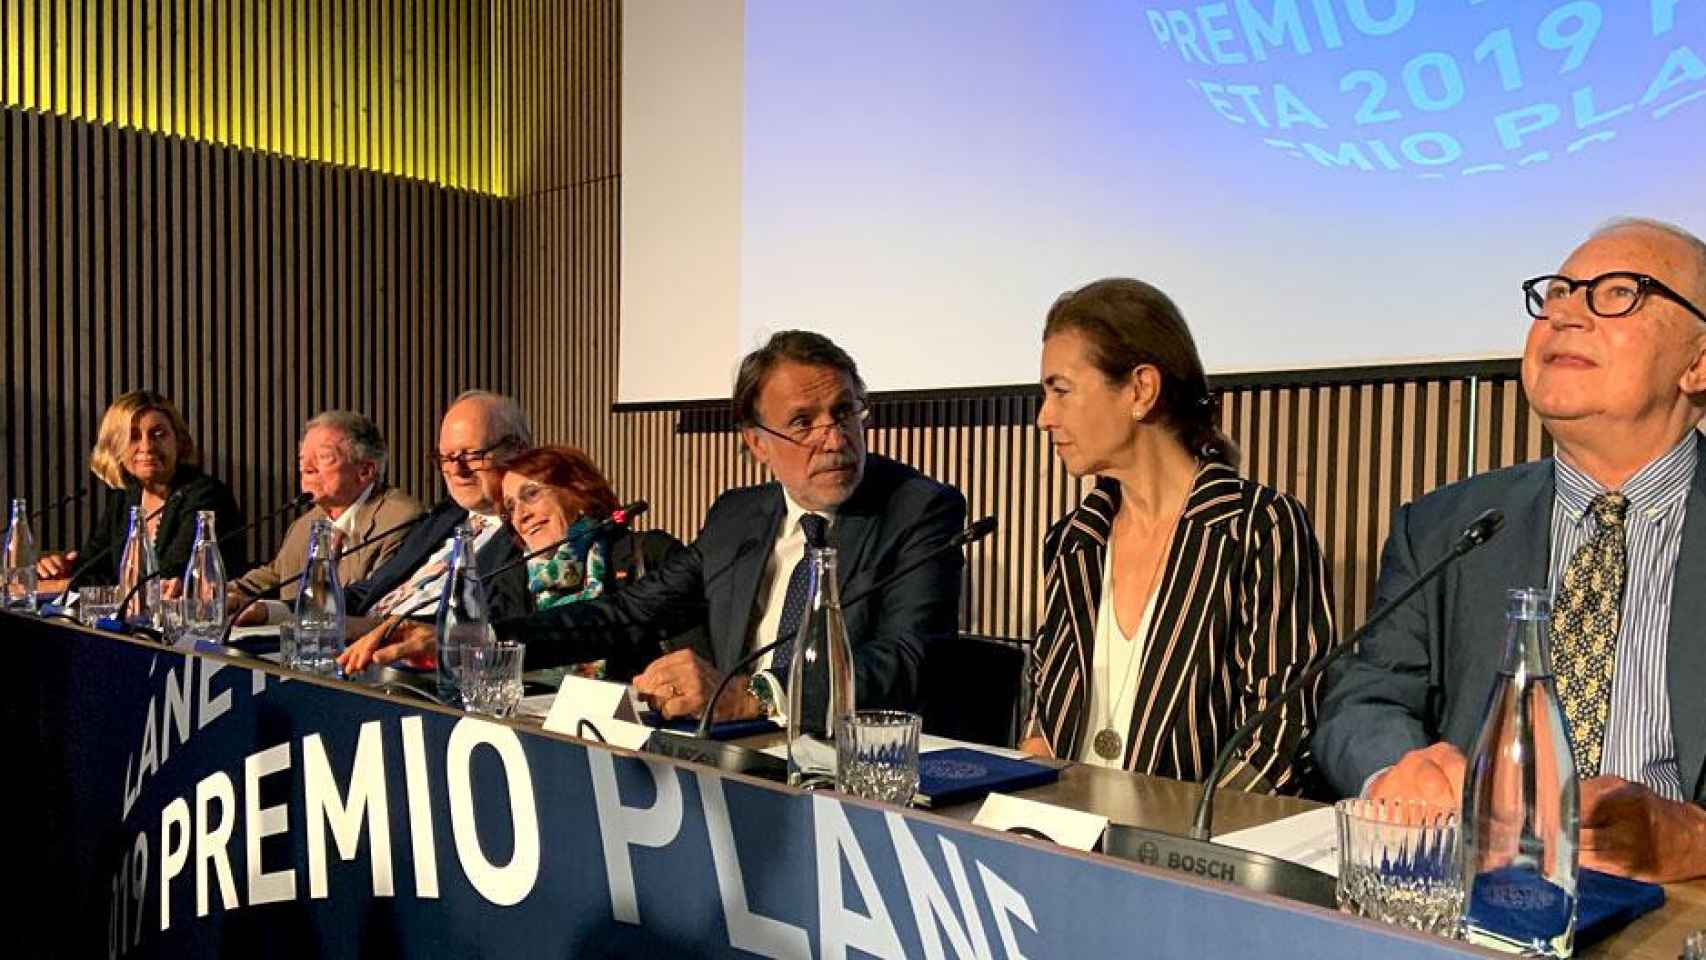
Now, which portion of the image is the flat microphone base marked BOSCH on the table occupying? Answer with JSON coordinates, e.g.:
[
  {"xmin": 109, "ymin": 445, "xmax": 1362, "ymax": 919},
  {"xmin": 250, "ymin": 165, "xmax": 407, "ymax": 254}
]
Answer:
[{"xmin": 1102, "ymin": 824, "xmax": 1338, "ymax": 911}]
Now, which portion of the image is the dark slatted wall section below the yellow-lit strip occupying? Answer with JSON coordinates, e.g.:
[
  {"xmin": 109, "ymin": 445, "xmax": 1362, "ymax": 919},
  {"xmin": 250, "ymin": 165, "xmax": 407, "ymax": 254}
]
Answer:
[{"xmin": 0, "ymin": 109, "xmax": 514, "ymax": 556}]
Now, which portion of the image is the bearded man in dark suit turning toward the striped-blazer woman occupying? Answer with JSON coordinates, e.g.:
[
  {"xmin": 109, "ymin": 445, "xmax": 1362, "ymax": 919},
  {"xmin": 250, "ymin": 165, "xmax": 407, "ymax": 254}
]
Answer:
[{"xmin": 346, "ymin": 331, "xmax": 966, "ymax": 718}]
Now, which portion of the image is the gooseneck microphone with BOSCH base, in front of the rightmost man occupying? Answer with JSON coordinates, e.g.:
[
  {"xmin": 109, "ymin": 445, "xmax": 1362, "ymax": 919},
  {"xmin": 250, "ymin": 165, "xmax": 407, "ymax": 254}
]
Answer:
[{"xmin": 1102, "ymin": 510, "xmax": 1505, "ymax": 907}]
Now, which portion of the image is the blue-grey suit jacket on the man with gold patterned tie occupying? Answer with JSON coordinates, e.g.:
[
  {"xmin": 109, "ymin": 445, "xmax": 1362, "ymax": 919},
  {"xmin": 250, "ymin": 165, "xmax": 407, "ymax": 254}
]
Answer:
[{"xmin": 1314, "ymin": 460, "xmax": 1706, "ymax": 803}]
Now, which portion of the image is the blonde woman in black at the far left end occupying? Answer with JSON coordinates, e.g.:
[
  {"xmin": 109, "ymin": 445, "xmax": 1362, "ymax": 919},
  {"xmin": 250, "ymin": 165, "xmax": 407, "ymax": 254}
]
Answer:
[{"xmin": 36, "ymin": 390, "xmax": 247, "ymax": 583}]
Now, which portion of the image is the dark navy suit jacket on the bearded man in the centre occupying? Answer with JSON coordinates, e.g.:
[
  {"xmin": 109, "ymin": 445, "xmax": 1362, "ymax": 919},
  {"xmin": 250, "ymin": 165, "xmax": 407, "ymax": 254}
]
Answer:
[{"xmin": 496, "ymin": 454, "xmax": 966, "ymax": 709}]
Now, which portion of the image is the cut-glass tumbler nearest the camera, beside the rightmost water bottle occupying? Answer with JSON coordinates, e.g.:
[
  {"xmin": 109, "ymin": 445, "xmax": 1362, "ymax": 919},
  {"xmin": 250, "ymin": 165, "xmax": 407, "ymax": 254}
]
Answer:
[{"xmin": 1334, "ymin": 800, "xmax": 1464, "ymax": 938}]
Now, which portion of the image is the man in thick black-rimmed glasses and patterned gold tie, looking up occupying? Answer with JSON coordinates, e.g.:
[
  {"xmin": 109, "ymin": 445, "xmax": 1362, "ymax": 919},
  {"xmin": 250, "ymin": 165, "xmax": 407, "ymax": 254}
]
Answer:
[{"xmin": 1314, "ymin": 220, "xmax": 1706, "ymax": 882}]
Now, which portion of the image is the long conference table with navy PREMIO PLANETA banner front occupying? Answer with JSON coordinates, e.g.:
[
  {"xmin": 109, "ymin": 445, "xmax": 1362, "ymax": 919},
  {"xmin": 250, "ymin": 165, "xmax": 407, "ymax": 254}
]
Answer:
[{"xmin": 13, "ymin": 614, "xmax": 1706, "ymax": 960}]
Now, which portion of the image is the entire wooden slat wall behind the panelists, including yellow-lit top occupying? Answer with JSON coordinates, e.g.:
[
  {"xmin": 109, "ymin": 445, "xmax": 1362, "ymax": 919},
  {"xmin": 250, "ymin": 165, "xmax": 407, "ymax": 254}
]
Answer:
[{"xmin": 0, "ymin": 0, "xmax": 1551, "ymax": 636}]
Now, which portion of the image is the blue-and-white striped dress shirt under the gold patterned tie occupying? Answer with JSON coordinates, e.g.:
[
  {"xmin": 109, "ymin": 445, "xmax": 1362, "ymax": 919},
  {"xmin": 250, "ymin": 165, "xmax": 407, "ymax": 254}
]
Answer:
[{"xmin": 1551, "ymin": 430, "xmax": 1706, "ymax": 800}]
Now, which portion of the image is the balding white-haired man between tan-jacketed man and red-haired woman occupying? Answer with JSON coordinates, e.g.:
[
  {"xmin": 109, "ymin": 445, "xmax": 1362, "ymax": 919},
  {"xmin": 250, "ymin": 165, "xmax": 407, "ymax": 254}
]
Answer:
[{"xmin": 343, "ymin": 390, "xmax": 532, "ymax": 624}]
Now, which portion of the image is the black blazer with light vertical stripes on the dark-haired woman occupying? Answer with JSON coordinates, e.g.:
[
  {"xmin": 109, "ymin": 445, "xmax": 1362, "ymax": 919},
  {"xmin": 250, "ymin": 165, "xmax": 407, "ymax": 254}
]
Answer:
[{"xmin": 1030, "ymin": 464, "xmax": 1336, "ymax": 793}]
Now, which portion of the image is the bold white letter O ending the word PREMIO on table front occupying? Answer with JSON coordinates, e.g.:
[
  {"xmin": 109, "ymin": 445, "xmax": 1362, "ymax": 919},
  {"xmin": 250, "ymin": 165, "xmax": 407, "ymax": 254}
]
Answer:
[{"xmin": 443, "ymin": 718, "xmax": 539, "ymax": 907}]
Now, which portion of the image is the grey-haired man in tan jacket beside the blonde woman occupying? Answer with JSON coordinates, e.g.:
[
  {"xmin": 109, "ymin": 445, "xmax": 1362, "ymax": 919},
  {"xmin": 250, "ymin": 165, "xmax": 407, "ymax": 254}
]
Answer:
[{"xmin": 230, "ymin": 409, "xmax": 421, "ymax": 624}]
